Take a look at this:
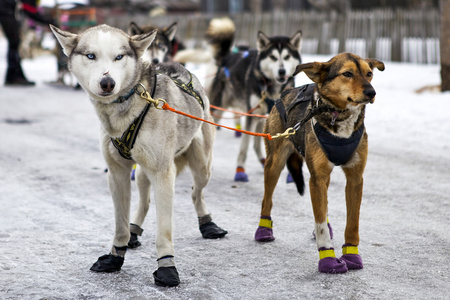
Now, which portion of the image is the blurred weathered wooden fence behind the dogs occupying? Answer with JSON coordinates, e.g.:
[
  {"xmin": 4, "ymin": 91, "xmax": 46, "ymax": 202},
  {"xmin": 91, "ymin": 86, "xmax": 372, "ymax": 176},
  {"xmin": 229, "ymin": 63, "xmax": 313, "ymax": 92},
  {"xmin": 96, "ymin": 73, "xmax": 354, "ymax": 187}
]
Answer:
[{"xmin": 108, "ymin": 9, "xmax": 440, "ymax": 64}]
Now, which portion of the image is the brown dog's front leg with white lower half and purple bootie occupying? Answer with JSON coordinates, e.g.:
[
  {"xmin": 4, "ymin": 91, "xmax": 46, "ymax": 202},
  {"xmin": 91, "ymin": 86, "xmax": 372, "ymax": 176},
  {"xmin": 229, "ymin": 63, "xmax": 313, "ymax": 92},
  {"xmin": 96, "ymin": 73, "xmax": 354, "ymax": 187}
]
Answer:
[{"xmin": 307, "ymin": 157, "xmax": 347, "ymax": 273}]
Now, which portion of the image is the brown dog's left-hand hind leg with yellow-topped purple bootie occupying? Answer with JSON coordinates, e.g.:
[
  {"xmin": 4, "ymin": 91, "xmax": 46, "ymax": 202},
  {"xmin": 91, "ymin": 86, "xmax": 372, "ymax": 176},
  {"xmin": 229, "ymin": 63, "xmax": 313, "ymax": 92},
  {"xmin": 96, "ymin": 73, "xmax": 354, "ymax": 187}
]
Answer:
[{"xmin": 255, "ymin": 141, "xmax": 290, "ymax": 242}]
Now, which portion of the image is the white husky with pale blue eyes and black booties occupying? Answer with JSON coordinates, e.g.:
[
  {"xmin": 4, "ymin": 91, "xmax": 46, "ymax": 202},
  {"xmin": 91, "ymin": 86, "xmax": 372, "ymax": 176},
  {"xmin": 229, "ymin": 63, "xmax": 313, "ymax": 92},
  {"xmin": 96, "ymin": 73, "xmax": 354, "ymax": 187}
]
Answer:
[{"xmin": 51, "ymin": 25, "xmax": 227, "ymax": 286}]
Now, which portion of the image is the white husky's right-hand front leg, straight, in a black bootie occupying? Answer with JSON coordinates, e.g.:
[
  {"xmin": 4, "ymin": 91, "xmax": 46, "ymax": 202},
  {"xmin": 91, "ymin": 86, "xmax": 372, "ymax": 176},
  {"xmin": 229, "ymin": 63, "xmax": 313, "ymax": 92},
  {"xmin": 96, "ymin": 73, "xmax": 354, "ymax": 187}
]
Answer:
[{"xmin": 151, "ymin": 163, "xmax": 180, "ymax": 286}]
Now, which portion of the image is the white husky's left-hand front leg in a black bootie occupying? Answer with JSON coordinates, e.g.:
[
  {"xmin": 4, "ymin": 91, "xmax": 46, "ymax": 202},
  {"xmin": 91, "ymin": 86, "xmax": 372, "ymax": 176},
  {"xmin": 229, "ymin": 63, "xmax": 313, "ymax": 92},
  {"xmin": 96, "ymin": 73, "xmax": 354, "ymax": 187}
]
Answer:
[{"xmin": 91, "ymin": 163, "xmax": 132, "ymax": 272}]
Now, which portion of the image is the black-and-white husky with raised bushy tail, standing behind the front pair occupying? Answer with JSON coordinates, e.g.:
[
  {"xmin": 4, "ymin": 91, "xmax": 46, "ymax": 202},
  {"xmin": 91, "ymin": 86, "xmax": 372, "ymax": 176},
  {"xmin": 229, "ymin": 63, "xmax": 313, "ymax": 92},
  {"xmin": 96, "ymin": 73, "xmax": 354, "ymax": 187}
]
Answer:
[{"xmin": 206, "ymin": 22, "xmax": 302, "ymax": 181}]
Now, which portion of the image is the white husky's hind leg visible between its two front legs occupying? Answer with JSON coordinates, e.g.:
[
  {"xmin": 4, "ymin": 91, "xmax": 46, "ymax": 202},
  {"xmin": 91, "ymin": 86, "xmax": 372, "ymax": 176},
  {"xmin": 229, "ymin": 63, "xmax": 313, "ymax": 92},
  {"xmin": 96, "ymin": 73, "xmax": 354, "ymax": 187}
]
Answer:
[{"xmin": 128, "ymin": 167, "xmax": 151, "ymax": 249}]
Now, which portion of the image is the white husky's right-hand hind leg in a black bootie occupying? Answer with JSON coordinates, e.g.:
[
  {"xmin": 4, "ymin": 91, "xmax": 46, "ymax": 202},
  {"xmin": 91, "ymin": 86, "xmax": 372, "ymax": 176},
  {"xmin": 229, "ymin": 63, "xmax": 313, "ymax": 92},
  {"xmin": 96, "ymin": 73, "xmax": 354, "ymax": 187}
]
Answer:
[{"xmin": 185, "ymin": 125, "xmax": 228, "ymax": 239}]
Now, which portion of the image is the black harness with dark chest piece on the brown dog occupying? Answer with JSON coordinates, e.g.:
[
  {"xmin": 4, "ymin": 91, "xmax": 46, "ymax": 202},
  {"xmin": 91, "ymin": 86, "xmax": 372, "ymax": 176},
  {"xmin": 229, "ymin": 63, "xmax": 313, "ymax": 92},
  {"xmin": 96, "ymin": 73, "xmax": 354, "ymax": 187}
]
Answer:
[{"xmin": 275, "ymin": 84, "xmax": 364, "ymax": 166}]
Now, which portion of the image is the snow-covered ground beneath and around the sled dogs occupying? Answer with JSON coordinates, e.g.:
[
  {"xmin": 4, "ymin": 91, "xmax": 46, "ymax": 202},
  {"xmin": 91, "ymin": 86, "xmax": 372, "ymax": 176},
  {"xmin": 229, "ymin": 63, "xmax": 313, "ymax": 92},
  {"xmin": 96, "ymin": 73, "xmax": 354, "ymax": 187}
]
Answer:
[{"xmin": 0, "ymin": 40, "xmax": 450, "ymax": 299}]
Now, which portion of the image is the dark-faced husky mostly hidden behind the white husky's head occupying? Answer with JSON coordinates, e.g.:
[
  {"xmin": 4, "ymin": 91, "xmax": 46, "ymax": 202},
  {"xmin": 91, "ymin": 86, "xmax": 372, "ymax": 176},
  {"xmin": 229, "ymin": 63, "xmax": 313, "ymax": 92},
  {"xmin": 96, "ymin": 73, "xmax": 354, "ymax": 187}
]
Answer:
[{"xmin": 128, "ymin": 22, "xmax": 184, "ymax": 64}]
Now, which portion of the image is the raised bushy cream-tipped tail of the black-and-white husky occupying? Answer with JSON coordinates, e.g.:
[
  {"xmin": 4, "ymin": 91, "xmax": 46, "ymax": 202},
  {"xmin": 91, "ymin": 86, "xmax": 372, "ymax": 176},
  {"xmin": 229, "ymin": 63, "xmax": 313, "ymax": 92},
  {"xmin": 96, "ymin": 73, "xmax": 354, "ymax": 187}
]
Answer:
[{"xmin": 205, "ymin": 17, "xmax": 236, "ymax": 66}]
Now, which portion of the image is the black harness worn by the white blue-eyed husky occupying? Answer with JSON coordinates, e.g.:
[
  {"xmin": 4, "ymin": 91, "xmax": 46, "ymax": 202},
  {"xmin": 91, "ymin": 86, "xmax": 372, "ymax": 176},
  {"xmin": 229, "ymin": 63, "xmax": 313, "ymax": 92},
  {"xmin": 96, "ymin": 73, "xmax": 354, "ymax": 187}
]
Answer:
[{"xmin": 111, "ymin": 73, "xmax": 205, "ymax": 160}]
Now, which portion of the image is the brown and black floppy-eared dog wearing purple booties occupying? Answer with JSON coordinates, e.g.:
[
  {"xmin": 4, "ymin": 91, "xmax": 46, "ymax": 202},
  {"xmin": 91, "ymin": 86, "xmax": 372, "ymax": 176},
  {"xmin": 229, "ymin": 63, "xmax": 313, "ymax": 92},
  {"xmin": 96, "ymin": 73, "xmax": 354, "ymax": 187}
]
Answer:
[{"xmin": 255, "ymin": 53, "xmax": 384, "ymax": 273}]
